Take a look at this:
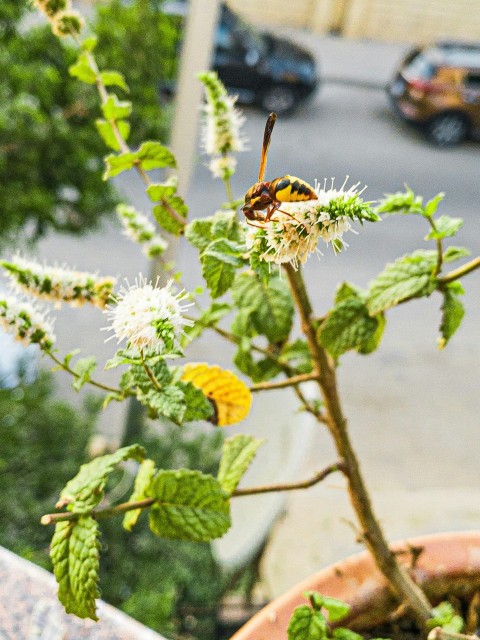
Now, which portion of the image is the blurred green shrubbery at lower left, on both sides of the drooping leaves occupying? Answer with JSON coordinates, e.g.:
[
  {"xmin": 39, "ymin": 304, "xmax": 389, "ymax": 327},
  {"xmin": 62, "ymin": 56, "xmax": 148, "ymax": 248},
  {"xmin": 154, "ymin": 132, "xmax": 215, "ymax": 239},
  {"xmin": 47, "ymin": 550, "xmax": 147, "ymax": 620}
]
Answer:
[{"xmin": 0, "ymin": 364, "xmax": 225, "ymax": 640}]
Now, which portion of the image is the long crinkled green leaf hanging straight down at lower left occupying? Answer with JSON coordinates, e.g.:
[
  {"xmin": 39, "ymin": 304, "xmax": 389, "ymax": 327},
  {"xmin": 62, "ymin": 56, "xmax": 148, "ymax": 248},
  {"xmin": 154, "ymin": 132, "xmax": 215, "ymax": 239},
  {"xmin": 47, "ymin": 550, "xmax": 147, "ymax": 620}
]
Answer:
[{"xmin": 50, "ymin": 517, "xmax": 100, "ymax": 620}]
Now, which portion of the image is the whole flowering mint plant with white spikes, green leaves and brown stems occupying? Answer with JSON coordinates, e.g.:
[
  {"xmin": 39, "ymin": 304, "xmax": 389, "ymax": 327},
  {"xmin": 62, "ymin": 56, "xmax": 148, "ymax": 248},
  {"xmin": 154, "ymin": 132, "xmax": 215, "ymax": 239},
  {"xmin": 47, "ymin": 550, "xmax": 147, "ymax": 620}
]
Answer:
[{"xmin": 0, "ymin": 0, "xmax": 480, "ymax": 639}]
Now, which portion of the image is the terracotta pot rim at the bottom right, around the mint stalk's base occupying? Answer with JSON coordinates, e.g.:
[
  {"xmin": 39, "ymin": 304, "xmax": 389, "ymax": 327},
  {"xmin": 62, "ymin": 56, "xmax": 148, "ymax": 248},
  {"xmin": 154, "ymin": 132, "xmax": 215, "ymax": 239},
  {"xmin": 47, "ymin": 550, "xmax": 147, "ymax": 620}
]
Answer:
[{"xmin": 231, "ymin": 531, "xmax": 480, "ymax": 640}]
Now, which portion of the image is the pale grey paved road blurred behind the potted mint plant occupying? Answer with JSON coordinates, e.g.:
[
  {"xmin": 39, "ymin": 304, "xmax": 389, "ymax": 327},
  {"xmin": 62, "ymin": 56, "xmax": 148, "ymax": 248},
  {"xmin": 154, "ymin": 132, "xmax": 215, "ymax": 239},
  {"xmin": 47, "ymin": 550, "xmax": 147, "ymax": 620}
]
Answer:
[{"xmin": 31, "ymin": 33, "xmax": 480, "ymax": 594}]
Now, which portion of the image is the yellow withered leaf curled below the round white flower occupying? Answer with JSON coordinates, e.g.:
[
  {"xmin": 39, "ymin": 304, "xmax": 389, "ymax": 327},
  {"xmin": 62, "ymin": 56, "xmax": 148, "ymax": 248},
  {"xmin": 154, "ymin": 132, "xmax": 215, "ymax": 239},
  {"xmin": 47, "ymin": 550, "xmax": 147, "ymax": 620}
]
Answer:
[{"xmin": 182, "ymin": 362, "xmax": 252, "ymax": 427}]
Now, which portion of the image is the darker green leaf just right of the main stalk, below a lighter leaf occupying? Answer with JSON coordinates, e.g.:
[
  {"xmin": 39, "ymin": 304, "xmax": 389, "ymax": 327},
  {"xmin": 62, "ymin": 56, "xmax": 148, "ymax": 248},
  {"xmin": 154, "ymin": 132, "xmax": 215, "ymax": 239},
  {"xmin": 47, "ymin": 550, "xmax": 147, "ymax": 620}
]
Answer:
[{"xmin": 318, "ymin": 286, "xmax": 384, "ymax": 358}]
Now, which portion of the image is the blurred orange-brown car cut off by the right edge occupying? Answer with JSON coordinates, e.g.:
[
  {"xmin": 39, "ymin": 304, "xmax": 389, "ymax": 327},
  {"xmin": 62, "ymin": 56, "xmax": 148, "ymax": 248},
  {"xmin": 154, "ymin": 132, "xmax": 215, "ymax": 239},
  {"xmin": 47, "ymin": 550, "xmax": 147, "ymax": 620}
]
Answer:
[{"xmin": 387, "ymin": 41, "xmax": 480, "ymax": 146}]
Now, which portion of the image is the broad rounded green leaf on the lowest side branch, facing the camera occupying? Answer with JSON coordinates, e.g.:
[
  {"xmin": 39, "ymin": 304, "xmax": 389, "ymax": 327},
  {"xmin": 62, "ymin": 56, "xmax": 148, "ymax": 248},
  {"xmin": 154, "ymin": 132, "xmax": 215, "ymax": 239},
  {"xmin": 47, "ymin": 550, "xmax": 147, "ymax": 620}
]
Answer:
[{"xmin": 149, "ymin": 469, "xmax": 230, "ymax": 542}]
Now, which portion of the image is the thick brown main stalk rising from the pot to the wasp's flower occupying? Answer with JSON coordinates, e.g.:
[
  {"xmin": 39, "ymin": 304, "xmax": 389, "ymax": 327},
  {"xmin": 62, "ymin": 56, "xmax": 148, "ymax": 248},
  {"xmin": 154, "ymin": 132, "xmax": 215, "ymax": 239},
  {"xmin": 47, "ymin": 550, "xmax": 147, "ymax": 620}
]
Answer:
[{"xmin": 284, "ymin": 264, "xmax": 431, "ymax": 627}]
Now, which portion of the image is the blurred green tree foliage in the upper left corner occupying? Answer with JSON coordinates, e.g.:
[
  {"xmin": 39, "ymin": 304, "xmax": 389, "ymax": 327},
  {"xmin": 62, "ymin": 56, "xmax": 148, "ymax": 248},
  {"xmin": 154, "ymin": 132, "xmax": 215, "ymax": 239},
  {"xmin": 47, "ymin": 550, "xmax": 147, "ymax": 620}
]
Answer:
[{"xmin": 0, "ymin": 0, "xmax": 178, "ymax": 248}]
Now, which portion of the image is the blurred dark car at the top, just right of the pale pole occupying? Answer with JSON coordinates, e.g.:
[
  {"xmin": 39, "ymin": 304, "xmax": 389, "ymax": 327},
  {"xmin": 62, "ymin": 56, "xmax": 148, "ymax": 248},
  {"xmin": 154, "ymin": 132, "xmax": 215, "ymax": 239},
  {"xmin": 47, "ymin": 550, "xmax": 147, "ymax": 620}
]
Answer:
[{"xmin": 162, "ymin": 2, "xmax": 318, "ymax": 114}]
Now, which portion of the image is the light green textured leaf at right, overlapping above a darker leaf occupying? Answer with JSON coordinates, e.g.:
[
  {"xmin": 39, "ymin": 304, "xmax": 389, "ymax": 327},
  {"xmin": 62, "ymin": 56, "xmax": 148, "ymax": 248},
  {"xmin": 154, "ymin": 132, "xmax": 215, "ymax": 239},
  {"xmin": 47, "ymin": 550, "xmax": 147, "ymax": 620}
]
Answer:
[{"xmin": 367, "ymin": 251, "xmax": 437, "ymax": 316}]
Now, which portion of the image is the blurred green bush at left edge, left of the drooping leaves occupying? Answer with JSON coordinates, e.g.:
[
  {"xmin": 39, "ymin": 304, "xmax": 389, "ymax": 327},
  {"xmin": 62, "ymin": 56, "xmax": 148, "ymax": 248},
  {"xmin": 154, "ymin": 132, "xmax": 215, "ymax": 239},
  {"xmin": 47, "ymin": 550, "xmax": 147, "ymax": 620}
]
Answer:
[{"xmin": 0, "ymin": 372, "xmax": 99, "ymax": 568}]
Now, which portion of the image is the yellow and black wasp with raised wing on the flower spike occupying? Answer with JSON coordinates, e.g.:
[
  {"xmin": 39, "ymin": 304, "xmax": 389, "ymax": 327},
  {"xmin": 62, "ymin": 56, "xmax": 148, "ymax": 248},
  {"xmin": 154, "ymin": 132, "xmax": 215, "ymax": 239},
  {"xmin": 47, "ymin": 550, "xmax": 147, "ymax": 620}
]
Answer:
[{"xmin": 242, "ymin": 113, "xmax": 317, "ymax": 229}]
